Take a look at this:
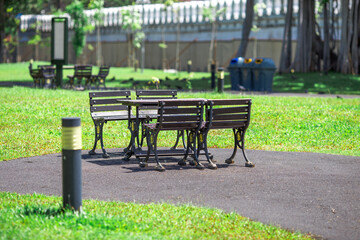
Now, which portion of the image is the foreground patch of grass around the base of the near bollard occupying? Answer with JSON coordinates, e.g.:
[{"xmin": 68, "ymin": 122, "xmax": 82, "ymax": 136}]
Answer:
[{"xmin": 0, "ymin": 192, "xmax": 311, "ymax": 239}]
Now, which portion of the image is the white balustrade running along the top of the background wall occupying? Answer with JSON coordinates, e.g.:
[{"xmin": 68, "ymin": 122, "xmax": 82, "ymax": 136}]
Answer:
[{"xmin": 20, "ymin": 0, "xmax": 298, "ymax": 32}]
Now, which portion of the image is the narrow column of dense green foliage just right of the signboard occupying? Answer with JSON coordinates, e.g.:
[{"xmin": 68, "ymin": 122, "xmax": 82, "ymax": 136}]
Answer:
[{"xmin": 65, "ymin": 0, "xmax": 91, "ymax": 57}]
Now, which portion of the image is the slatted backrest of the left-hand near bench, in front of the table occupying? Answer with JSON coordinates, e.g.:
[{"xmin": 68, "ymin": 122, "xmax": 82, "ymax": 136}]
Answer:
[{"xmin": 156, "ymin": 99, "xmax": 204, "ymax": 130}]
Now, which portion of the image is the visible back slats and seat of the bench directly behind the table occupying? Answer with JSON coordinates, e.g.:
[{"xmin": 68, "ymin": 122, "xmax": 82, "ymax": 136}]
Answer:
[{"xmin": 136, "ymin": 90, "xmax": 177, "ymax": 118}]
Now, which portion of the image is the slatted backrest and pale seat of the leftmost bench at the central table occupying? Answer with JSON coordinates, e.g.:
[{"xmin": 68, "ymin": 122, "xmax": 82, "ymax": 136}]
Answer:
[{"xmin": 89, "ymin": 90, "xmax": 131, "ymax": 118}]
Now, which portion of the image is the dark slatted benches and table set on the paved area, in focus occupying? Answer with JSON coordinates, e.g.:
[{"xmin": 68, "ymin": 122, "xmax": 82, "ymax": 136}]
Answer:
[{"xmin": 89, "ymin": 90, "xmax": 254, "ymax": 171}]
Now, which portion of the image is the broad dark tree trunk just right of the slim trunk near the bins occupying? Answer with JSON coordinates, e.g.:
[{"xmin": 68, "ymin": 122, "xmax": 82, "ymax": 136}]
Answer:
[{"xmin": 294, "ymin": 0, "xmax": 315, "ymax": 72}]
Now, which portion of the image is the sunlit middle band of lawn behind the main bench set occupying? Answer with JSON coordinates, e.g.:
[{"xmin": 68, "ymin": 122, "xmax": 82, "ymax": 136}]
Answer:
[{"xmin": 0, "ymin": 87, "xmax": 360, "ymax": 160}]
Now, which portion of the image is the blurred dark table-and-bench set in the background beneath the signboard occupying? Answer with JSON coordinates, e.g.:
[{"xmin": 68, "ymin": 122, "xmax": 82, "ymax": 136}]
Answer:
[{"xmin": 29, "ymin": 64, "xmax": 110, "ymax": 89}]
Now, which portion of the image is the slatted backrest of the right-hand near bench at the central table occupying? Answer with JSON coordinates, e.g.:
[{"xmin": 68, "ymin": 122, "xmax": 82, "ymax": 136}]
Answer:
[{"xmin": 206, "ymin": 99, "xmax": 251, "ymax": 129}]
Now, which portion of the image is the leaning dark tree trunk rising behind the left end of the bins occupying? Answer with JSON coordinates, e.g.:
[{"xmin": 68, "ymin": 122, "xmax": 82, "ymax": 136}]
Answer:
[{"xmin": 237, "ymin": 0, "xmax": 254, "ymax": 57}]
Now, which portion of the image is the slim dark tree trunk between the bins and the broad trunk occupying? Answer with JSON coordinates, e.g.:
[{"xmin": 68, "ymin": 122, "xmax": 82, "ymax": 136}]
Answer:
[{"xmin": 279, "ymin": 0, "xmax": 293, "ymax": 73}]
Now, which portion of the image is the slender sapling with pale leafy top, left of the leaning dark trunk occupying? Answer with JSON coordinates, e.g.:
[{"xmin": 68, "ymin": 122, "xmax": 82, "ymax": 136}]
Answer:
[{"xmin": 202, "ymin": 4, "xmax": 226, "ymax": 72}]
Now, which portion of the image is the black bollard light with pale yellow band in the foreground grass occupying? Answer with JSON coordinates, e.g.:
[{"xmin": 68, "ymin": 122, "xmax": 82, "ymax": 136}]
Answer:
[{"xmin": 62, "ymin": 118, "xmax": 82, "ymax": 211}]
